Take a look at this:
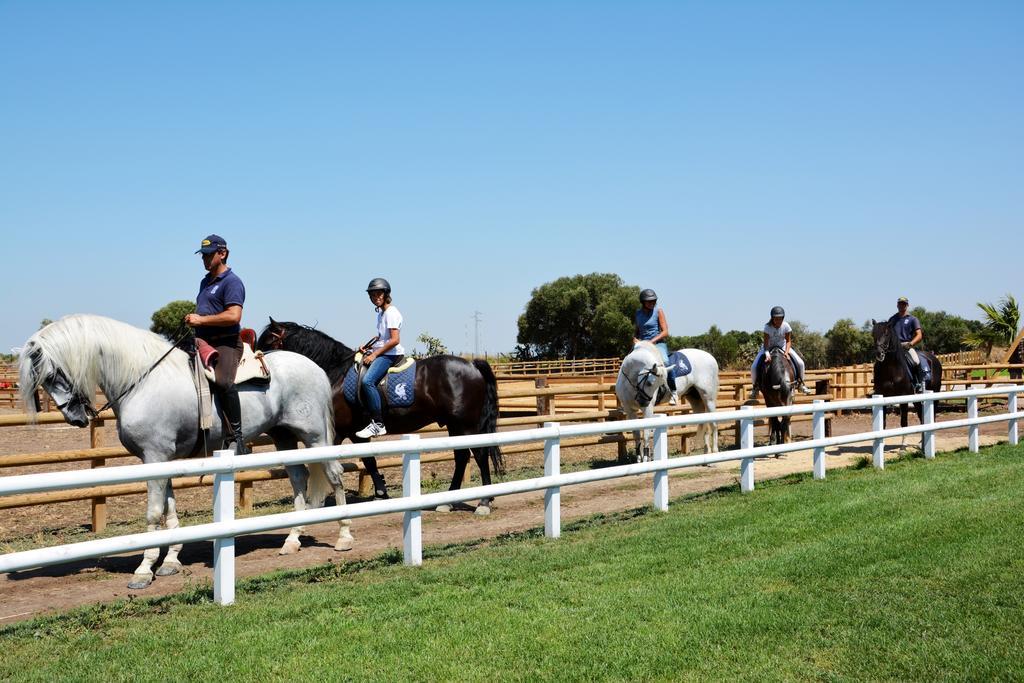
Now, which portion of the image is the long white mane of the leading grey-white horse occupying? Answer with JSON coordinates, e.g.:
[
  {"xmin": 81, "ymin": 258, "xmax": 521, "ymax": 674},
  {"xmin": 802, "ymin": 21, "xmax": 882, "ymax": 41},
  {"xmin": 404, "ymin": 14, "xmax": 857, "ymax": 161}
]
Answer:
[{"xmin": 18, "ymin": 313, "xmax": 187, "ymax": 415}]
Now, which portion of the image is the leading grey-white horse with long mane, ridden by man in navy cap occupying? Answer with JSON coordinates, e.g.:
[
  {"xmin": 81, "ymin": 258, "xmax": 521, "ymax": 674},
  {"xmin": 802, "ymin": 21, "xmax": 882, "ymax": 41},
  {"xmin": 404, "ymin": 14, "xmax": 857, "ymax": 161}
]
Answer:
[{"xmin": 19, "ymin": 314, "xmax": 353, "ymax": 589}]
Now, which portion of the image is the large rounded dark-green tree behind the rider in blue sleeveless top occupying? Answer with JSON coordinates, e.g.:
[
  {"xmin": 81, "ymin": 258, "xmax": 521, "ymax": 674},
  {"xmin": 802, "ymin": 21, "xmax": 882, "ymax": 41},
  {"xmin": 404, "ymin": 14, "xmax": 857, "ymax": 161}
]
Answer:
[{"xmin": 515, "ymin": 272, "xmax": 640, "ymax": 358}]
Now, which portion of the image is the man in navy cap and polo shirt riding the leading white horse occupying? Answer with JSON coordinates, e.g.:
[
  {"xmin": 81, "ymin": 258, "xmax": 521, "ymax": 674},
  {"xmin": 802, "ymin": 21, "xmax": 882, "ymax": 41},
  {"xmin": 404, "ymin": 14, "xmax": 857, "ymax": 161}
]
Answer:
[{"xmin": 185, "ymin": 234, "xmax": 249, "ymax": 456}]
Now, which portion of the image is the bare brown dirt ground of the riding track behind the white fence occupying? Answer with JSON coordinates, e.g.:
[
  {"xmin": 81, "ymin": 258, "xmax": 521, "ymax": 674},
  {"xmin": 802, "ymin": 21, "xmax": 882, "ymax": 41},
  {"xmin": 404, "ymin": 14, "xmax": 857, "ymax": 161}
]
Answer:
[{"xmin": 0, "ymin": 405, "xmax": 1006, "ymax": 626}]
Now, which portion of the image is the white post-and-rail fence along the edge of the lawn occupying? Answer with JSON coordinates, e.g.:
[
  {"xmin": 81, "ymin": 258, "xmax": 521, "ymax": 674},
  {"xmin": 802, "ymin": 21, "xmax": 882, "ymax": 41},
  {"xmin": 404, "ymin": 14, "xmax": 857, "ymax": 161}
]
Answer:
[{"xmin": 0, "ymin": 386, "xmax": 1024, "ymax": 604}]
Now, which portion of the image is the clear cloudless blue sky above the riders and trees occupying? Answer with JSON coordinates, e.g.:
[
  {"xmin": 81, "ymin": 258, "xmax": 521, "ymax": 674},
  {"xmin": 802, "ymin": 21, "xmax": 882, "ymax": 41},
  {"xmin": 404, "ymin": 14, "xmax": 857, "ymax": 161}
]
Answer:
[{"xmin": 0, "ymin": 0, "xmax": 1024, "ymax": 352}]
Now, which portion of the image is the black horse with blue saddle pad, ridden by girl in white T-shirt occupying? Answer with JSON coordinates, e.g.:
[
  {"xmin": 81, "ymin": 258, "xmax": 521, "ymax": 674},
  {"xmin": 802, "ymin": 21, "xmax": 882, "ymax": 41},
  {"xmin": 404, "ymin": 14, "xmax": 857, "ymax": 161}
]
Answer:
[{"xmin": 256, "ymin": 317, "xmax": 503, "ymax": 514}]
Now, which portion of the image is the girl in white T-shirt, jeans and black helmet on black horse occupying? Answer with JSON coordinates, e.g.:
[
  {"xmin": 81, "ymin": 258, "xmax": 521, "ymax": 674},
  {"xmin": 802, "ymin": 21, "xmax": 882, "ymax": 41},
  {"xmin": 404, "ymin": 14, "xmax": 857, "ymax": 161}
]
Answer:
[{"xmin": 355, "ymin": 278, "xmax": 406, "ymax": 438}]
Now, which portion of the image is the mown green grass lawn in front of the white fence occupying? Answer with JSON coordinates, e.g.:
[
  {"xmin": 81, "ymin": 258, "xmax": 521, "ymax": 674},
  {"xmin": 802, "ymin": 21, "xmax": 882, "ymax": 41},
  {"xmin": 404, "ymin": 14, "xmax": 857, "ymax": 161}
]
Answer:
[{"xmin": 0, "ymin": 445, "xmax": 1024, "ymax": 681}]
